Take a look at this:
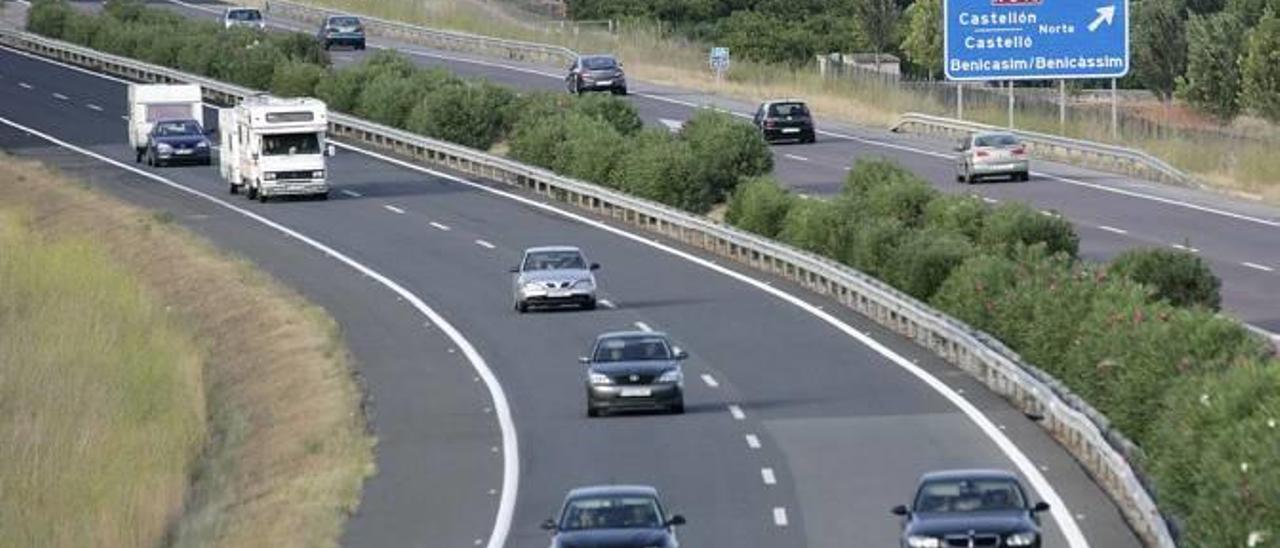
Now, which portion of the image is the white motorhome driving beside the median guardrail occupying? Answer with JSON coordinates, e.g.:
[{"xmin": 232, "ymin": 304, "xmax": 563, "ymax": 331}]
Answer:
[{"xmin": 218, "ymin": 95, "xmax": 334, "ymax": 202}]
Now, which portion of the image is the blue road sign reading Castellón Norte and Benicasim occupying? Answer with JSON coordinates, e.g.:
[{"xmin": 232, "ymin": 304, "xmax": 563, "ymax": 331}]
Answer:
[{"xmin": 942, "ymin": 0, "xmax": 1129, "ymax": 81}]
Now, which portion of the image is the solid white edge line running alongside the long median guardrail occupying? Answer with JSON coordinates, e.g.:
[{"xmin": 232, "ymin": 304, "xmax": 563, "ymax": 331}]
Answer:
[{"xmin": 335, "ymin": 142, "xmax": 1089, "ymax": 548}]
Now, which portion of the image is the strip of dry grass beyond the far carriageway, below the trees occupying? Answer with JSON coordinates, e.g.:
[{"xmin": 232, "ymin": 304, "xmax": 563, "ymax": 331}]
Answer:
[{"xmin": 294, "ymin": 0, "xmax": 1280, "ymax": 198}]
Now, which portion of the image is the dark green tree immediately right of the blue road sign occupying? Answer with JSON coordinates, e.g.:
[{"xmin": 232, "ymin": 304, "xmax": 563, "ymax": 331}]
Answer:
[{"xmin": 1132, "ymin": 0, "xmax": 1187, "ymax": 100}]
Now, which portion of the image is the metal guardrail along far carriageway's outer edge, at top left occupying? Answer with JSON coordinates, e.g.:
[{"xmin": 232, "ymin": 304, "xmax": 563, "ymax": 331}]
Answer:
[{"xmin": 266, "ymin": 0, "xmax": 577, "ymax": 68}]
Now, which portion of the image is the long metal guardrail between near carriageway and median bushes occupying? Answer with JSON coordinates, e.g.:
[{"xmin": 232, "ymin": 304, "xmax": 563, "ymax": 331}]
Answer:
[{"xmin": 0, "ymin": 29, "xmax": 1175, "ymax": 548}]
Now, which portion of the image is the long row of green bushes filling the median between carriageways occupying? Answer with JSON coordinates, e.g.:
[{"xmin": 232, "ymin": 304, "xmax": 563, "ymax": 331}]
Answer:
[{"xmin": 33, "ymin": 0, "xmax": 1280, "ymax": 547}]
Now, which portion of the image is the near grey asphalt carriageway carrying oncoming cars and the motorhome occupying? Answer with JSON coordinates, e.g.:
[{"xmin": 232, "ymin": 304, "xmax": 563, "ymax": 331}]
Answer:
[{"xmin": 0, "ymin": 43, "xmax": 1138, "ymax": 548}]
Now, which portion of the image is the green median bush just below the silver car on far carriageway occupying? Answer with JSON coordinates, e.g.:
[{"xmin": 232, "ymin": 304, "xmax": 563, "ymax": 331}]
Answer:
[{"xmin": 978, "ymin": 204, "xmax": 1080, "ymax": 257}]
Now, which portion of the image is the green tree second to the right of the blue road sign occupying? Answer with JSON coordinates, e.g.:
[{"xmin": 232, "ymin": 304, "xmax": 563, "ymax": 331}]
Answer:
[{"xmin": 1178, "ymin": 12, "xmax": 1245, "ymax": 119}]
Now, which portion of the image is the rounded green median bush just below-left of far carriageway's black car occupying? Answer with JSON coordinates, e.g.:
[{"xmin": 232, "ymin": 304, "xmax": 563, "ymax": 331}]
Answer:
[{"xmin": 680, "ymin": 109, "xmax": 773, "ymax": 202}]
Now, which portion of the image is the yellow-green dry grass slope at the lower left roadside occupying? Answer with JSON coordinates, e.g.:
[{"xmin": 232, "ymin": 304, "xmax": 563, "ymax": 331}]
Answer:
[{"xmin": 0, "ymin": 155, "xmax": 372, "ymax": 547}]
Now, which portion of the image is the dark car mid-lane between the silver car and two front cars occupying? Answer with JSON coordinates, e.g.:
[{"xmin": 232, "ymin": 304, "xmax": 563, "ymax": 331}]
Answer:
[{"xmin": 577, "ymin": 332, "xmax": 689, "ymax": 416}]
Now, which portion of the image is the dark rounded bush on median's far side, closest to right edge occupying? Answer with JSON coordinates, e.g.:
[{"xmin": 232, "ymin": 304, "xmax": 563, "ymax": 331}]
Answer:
[{"xmin": 1111, "ymin": 248, "xmax": 1222, "ymax": 310}]
